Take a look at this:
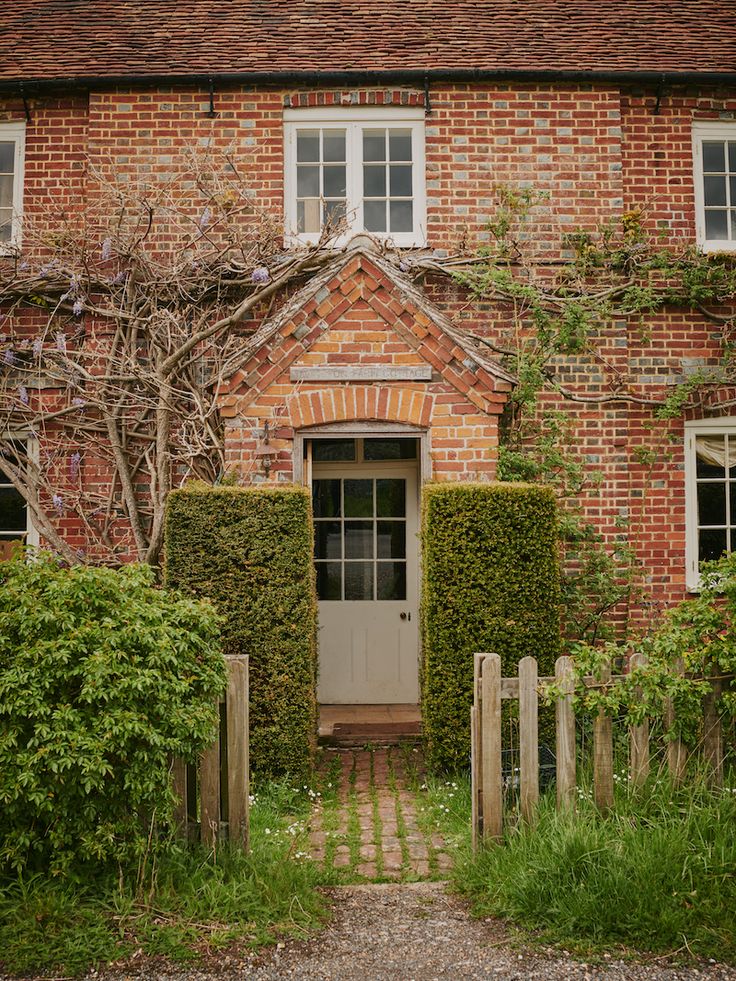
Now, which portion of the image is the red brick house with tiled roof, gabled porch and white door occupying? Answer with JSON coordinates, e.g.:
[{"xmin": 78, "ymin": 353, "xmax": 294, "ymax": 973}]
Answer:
[{"xmin": 0, "ymin": 0, "xmax": 736, "ymax": 703}]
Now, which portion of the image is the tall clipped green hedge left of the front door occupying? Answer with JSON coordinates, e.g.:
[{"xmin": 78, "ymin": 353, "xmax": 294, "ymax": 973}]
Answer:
[{"xmin": 166, "ymin": 483, "xmax": 317, "ymax": 777}]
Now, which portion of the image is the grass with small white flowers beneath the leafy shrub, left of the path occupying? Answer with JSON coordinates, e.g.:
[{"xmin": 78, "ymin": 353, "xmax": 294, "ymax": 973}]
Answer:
[{"xmin": 0, "ymin": 784, "xmax": 324, "ymax": 976}]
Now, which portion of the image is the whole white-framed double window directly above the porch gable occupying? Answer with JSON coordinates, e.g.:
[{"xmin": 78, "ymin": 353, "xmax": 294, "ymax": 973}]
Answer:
[{"xmin": 284, "ymin": 106, "xmax": 427, "ymax": 247}]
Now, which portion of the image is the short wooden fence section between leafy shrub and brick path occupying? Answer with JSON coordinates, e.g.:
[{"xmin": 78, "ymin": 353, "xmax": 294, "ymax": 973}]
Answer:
[{"xmin": 172, "ymin": 656, "xmax": 250, "ymax": 850}]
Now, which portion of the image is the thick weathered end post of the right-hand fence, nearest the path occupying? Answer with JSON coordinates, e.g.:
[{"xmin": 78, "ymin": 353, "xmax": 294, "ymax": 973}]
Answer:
[{"xmin": 480, "ymin": 654, "xmax": 503, "ymax": 840}]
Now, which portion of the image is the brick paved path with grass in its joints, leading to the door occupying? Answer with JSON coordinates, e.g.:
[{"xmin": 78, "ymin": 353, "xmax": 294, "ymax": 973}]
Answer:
[{"xmin": 310, "ymin": 747, "xmax": 451, "ymax": 881}]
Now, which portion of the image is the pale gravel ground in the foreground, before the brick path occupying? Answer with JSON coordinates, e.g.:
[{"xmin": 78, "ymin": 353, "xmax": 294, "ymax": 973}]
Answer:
[{"xmin": 90, "ymin": 882, "xmax": 736, "ymax": 981}]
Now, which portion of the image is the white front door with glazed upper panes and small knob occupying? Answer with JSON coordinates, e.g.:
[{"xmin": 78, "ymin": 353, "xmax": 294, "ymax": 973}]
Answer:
[{"xmin": 312, "ymin": 444, "xmax": 419, "ymax": 704}]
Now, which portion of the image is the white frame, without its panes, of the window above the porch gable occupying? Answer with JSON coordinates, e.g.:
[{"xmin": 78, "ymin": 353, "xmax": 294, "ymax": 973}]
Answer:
[{"xmin": 284, "ymin": 106, "xmax": 427, "ymax": 248}]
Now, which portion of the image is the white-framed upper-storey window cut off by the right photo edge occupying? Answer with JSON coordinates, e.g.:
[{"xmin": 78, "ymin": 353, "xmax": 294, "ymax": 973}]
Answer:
[{"xmin": 693, "ymin": 121, "xmax": 736, "ymax": 252}]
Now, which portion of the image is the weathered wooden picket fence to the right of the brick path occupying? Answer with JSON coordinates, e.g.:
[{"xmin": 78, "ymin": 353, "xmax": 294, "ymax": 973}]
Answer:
[{"xmin": 470, "ymin": 654, "xmax": 724, "ymax": 847}]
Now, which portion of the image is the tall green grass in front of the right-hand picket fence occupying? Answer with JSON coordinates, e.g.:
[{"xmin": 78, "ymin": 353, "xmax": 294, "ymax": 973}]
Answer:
[{"xmin": 455, "ymin": 775, "xmax": 736, "ymax": 960}]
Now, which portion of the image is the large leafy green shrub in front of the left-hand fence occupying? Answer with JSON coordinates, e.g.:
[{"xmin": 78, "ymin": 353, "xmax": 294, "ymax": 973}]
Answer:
[{"xmin": 0, "ymin": 555, "xmax": 224, "ymax": 872}]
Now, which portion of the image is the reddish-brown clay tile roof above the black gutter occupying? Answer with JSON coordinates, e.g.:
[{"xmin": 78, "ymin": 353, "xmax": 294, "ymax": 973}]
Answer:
[{"xmin": 0, "ymin": 0, "xmax": 736, "ymax": 83}]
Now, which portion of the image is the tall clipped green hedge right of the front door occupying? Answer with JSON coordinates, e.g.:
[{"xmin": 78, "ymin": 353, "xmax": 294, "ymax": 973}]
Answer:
[{"xmin": 422, "ymin": 483, "xmax": 560, "ymax": 770}]
